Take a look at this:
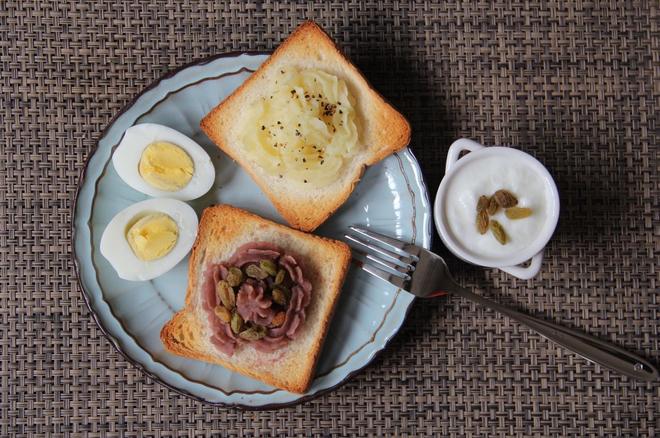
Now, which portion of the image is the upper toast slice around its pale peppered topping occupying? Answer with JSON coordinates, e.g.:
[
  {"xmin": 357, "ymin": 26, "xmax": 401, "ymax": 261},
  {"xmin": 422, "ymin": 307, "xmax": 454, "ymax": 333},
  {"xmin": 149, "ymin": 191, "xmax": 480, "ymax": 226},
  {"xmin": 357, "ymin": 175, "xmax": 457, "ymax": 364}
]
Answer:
[{"xmin": 201, "ymin": 21, "xmax": 411, "ymax": 231}]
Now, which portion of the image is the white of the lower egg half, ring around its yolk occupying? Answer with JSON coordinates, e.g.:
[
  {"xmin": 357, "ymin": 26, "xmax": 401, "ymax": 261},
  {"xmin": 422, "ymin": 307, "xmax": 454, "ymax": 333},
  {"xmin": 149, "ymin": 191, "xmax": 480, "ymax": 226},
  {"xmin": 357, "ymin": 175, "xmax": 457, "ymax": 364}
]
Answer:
[{"xmin": 101, "ymin": 198, "xmax": 198, "ymax": 281}]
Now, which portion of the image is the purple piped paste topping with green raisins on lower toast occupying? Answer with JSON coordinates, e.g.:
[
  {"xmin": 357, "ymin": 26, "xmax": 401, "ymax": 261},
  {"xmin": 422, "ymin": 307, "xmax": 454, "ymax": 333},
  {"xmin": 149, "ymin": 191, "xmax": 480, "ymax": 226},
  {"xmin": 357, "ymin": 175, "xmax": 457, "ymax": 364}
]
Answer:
[{"xmin": 202, "ymin": 242, "xmax": 312, "ymax": 356}]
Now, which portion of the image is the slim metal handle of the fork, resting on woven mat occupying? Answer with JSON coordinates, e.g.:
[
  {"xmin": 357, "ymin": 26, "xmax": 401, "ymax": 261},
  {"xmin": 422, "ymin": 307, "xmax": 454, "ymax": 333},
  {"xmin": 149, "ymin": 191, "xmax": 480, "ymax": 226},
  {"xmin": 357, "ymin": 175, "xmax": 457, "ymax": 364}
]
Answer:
[{"xmin": 447, "ymin": 285, "xmax": 658, "ymax": 382}]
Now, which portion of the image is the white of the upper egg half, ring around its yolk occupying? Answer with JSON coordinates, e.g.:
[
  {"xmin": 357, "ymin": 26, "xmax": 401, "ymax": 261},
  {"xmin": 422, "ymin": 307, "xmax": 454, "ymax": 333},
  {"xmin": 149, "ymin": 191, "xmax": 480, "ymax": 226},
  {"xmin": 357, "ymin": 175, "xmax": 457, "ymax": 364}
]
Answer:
[{"xmin": 112, "ymin": 123, "xmax": 215, "ymax": 201}]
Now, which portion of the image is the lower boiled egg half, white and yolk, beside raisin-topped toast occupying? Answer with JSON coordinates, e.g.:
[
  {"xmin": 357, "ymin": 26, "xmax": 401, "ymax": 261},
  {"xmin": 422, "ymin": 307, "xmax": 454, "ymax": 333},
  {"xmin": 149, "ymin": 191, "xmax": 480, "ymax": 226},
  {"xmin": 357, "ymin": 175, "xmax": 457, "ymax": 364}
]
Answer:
[{"xmin": 101, "ymin": 198, "xmax": 198, "ymax": 281}]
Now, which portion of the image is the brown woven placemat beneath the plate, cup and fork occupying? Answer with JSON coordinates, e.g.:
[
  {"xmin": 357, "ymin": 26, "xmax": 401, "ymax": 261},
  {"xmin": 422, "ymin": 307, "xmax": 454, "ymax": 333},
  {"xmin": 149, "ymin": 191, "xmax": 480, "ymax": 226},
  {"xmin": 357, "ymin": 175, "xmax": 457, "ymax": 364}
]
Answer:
[{"xmin": 0, "ymin": 0, "xmax": 660, "ymax": 437}]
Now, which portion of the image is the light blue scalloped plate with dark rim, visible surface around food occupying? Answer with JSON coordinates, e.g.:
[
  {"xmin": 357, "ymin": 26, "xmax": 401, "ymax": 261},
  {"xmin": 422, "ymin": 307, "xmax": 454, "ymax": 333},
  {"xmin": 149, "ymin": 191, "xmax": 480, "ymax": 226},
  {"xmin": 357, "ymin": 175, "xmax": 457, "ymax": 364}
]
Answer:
[{"xmin": 73, "ymin": 53, "xmax": 431, "ymax": 409}]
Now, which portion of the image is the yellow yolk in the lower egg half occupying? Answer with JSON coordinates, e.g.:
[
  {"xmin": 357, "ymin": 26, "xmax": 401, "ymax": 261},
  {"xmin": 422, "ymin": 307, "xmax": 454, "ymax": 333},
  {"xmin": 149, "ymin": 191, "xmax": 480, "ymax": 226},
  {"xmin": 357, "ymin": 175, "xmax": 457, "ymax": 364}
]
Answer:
[{"xmin": 126, "ymin": 213, "xmax": 179, "ymax": 261}]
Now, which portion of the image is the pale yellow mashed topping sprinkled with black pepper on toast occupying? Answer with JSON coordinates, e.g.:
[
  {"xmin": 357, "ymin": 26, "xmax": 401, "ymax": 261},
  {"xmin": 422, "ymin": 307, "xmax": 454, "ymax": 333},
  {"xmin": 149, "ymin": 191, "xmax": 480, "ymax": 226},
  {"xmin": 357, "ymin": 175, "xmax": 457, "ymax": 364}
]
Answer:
[{"xmin": 242, "ymin": 69, "xmax": 361, "ymax": 187}]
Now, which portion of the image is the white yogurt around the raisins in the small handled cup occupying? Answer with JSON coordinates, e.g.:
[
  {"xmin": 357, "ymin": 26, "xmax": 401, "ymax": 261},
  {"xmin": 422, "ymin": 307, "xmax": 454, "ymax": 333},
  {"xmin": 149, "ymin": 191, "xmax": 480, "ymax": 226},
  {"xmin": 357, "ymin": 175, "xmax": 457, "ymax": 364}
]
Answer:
[{"xmin": 443, "ymin": 155, "xmax": 552, "ymax": 260}]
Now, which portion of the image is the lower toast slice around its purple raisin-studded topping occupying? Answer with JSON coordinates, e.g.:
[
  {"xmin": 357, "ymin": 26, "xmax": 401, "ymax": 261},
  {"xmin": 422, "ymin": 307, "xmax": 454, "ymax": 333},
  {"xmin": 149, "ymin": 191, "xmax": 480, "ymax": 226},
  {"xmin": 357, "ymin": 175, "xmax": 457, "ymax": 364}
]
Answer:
[{"xmin": 160, "ymin": 205, "xmax": 351, "ymax": 393}]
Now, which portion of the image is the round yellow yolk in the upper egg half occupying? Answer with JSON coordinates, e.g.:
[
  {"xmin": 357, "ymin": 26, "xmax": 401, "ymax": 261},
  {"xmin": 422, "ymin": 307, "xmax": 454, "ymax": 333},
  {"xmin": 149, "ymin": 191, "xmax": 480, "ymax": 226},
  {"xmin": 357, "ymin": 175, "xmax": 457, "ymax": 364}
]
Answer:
[{"xmin": 138, "ymin": 141, "xmax": 194, "ymax": 192}]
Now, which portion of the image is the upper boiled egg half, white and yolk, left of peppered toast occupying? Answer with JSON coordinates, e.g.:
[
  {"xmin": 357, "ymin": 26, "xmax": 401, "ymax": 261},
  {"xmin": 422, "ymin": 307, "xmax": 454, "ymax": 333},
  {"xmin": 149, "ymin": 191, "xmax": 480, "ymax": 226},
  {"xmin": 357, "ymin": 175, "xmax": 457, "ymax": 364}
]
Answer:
[{"xmin": 112, "ymin": 123, "xmax": 215, "ymax": 201}]
